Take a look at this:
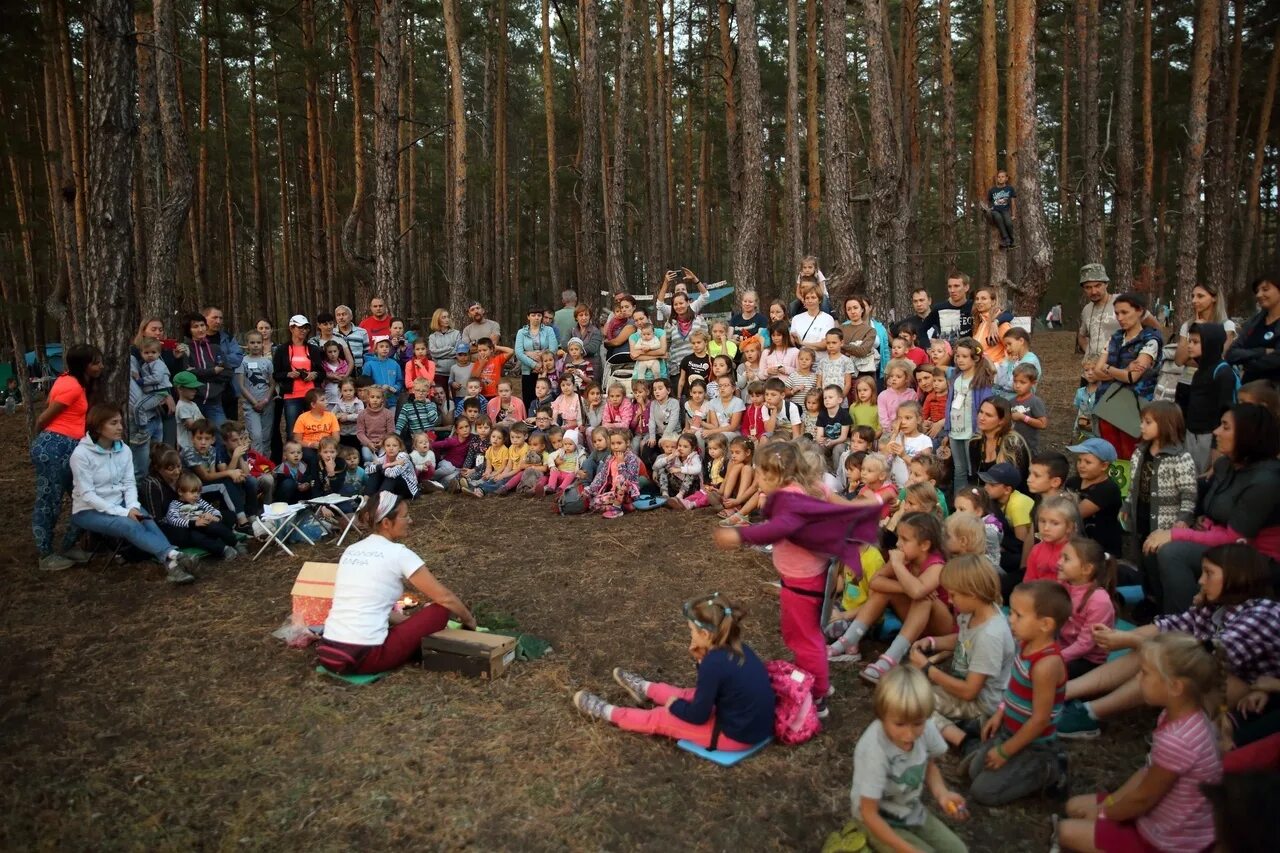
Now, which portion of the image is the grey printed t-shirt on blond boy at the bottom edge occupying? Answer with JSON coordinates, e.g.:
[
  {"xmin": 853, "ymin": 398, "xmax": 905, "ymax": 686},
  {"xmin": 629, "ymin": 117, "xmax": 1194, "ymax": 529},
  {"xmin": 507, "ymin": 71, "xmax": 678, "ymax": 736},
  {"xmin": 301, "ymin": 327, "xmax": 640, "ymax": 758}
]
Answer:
[{"xmin": 849, "ymin": 720, "xmax": 947, "ymax": 826}]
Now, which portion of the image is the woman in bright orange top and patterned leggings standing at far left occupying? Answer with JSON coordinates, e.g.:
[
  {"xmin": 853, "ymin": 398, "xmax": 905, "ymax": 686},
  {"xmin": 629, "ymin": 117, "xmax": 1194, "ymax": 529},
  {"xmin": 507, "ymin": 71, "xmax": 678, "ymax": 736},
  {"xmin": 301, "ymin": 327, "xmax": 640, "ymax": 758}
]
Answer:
[{"xmin": 31, "ymin": 343, "xmax": 102, "ymax": 571}]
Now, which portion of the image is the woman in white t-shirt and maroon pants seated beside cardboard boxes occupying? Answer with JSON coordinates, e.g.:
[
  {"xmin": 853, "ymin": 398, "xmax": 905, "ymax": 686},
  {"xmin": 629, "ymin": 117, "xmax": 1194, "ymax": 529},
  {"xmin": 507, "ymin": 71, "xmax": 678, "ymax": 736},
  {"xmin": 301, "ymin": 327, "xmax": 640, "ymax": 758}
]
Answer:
[{"xmin": 316, "ymin": 492, "xmax": 476, "ymax": 675}]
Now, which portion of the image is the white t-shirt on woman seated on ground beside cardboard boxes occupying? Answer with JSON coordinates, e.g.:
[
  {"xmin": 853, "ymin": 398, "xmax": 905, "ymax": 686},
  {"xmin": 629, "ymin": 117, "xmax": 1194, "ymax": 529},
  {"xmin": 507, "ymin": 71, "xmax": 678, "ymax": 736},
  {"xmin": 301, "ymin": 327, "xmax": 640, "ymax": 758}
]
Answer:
[{"xmin": 324, "ymin": 533, "xmax": 422, "ymax": 646}]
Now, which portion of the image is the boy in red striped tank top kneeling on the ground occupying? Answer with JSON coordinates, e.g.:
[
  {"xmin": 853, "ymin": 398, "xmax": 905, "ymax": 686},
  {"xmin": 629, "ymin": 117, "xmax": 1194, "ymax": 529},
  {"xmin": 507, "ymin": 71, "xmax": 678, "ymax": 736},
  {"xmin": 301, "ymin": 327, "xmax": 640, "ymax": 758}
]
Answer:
[{"xmin": 969, "ymin": 580, "xmax": 1071, "ymax": 806}]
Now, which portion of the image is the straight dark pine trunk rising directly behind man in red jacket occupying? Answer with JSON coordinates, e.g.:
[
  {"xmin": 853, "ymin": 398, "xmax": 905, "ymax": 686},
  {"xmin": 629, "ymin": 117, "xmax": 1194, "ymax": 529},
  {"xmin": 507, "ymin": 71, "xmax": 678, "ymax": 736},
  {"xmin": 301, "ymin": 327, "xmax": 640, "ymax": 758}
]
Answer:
[{"xmin": 374, "ymin": 0, "xmax": 406, "ymax": 310}]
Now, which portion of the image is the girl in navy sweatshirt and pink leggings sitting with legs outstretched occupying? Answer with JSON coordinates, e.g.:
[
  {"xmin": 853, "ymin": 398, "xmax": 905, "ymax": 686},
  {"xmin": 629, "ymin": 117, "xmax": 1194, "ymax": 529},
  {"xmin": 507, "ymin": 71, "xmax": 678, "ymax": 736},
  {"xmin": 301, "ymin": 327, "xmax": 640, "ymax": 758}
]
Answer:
[{"xmin": 573, "ymin": 593, "xmax": 774, "ymax": 751}]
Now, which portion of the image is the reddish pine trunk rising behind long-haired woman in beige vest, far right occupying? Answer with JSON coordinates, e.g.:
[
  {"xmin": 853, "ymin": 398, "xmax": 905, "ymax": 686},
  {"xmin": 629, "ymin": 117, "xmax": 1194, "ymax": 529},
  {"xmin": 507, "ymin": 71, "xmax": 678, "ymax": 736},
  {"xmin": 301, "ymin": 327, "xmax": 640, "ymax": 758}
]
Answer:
[{"xmin": 1176, "ymin": 0, "xmax": 1220, "ymax": 323}]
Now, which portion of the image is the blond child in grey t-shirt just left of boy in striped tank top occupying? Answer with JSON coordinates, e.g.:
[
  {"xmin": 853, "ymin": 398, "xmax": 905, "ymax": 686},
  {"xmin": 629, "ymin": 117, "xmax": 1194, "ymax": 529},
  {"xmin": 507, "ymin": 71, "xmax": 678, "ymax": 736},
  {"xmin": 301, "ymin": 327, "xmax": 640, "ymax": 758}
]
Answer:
[{"xmin": 911, "ymin": 555, "xmax": 1015, "ymax": 745}]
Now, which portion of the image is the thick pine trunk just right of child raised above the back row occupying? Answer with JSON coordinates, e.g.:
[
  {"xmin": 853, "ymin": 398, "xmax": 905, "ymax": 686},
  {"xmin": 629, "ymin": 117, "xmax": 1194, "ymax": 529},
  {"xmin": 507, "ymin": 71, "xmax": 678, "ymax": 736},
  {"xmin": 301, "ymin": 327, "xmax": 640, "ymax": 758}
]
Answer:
[{"xmin": 810, "ymin": 0, "xmax": 863, "ymax": 292}]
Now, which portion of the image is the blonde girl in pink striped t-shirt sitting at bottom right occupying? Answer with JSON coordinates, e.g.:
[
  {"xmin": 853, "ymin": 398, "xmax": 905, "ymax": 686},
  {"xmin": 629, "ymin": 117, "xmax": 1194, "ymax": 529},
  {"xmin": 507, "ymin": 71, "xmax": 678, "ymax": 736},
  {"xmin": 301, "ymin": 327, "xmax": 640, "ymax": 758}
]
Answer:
[{"xmin": 1057, "ymin": 633, "xmax": 1223, "ymax": 852}]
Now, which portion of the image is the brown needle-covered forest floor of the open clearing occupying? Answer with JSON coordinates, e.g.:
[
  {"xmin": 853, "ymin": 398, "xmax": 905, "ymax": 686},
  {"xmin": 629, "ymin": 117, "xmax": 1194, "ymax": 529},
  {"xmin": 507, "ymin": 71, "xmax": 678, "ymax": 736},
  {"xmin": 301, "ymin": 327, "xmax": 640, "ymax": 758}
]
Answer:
[{"xmin": 0, "ymin": 333, "xmax": 1151, "ymax": 850}]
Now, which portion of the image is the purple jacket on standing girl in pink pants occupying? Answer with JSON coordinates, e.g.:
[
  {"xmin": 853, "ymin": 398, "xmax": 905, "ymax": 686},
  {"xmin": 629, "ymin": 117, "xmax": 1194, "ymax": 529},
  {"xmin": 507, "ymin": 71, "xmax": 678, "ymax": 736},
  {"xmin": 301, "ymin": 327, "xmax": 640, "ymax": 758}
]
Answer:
[{"xmin": 737, "ymin": 492, "xmax": 881, "ymax": 571}]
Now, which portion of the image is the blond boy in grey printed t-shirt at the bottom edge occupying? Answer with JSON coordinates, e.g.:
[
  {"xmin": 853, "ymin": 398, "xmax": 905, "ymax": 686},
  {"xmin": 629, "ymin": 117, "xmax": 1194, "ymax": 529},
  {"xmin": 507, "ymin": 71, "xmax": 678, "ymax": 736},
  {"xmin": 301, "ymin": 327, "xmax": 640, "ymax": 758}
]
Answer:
[{"xmin": 850, "ymin": 666, "xmax": 969, "ymax": 853}]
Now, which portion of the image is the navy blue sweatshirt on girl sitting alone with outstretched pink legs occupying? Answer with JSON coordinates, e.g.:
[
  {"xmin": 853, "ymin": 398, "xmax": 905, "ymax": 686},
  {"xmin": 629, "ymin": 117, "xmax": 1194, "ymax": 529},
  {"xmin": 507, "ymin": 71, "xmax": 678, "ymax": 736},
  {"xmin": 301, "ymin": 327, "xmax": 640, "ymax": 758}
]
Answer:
[{"xmin": 671, "ymin": 643, "xmax": 773, "ymax": 743}]
